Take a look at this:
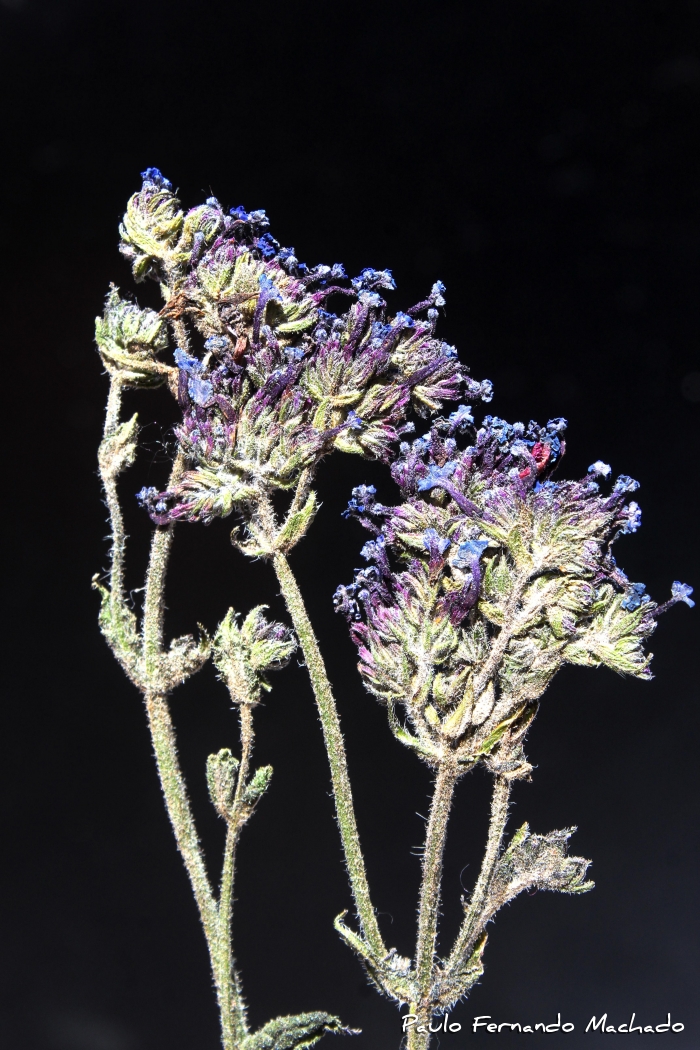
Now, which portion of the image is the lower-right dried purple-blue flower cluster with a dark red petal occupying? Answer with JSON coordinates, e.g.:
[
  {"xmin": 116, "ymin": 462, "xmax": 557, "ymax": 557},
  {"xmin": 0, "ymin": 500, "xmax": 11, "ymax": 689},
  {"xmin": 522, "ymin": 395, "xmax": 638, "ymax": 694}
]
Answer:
[{"xmin": 335, "ymin": 405, "xmax": 693, "ymax": 775}]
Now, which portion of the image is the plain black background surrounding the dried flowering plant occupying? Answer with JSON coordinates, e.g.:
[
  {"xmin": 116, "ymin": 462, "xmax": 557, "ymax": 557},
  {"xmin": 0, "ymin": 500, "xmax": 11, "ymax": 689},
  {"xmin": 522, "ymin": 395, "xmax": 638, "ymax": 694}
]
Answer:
[{"xmin": 0, "ymin": 0, "xmax": 700, "ymax": 1050}]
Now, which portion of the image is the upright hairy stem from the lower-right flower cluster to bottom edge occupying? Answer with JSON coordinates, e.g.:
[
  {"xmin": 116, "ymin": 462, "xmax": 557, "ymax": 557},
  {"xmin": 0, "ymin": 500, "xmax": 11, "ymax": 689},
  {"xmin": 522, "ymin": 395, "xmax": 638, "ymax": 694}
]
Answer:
[{"xmin": 407, "ymin": 762, "xmax": 460, "ymax": 1050}]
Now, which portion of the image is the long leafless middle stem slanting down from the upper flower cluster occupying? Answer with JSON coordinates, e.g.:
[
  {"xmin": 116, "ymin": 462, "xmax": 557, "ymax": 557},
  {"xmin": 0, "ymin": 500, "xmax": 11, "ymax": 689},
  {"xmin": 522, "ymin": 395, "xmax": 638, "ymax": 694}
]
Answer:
[{"xmin": 274, "ymin": 551, "xmax": 386, "ymax": 958}]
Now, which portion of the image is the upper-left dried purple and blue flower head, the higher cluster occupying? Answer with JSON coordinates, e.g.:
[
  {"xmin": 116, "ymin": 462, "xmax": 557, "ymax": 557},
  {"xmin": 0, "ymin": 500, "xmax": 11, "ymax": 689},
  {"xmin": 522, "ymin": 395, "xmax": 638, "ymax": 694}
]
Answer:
[{"xmin": 110, "ymin": 168, "xmax": 491, "ymax": 524}]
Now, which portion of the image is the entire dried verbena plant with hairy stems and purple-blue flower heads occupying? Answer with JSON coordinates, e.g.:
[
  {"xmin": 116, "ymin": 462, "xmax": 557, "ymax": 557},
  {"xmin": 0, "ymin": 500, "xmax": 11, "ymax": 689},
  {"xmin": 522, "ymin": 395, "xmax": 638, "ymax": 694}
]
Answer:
[{"xmin": 94, "ymin": 168, "xmax": 694, "ymax": 1050}]
